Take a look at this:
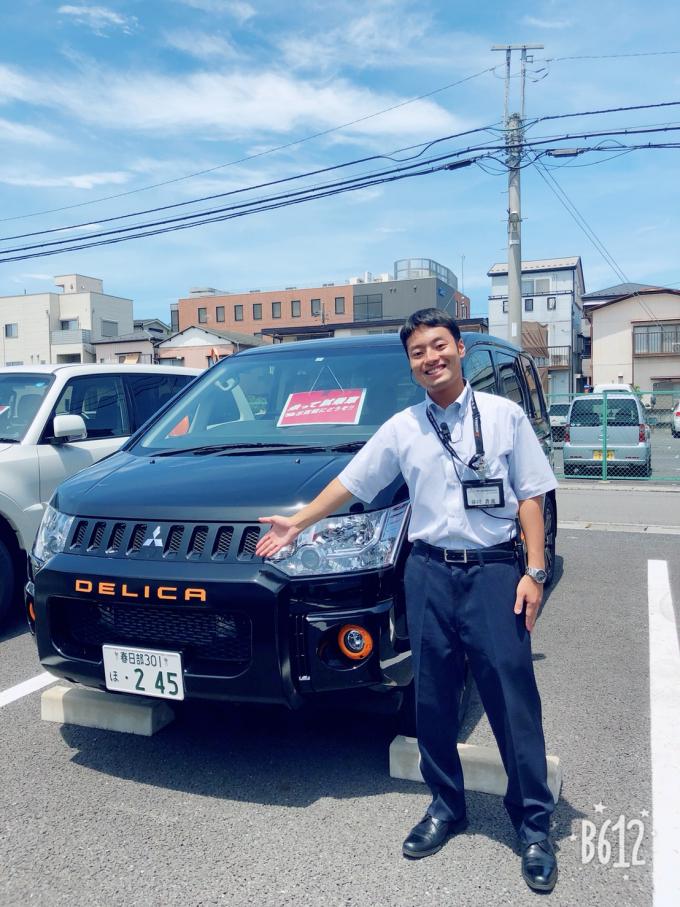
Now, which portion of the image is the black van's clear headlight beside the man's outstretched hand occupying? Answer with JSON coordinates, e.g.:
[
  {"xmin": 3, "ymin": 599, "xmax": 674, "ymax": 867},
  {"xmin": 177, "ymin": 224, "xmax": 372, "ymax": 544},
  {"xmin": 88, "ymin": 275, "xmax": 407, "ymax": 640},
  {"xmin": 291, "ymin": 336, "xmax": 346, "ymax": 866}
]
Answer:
[{"xmin": 266, "ymin": 501, "xmax": 409, "ymax": 576}]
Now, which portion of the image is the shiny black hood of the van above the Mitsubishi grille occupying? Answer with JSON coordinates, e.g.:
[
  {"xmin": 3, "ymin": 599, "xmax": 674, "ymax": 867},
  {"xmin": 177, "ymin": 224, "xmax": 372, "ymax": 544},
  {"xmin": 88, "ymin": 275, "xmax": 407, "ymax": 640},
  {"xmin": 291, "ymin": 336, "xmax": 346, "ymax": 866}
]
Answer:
[{"xmin": 53, "ymin": 451, "xmax": 405, "ymax": 522}]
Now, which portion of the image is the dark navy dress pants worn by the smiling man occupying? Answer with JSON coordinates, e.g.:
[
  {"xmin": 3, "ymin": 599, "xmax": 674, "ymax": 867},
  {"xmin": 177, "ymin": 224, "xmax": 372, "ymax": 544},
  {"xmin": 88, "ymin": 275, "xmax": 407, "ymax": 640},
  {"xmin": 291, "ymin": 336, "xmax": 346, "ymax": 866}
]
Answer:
[{"xmin": 405, "ymin": 546, "xmax": 554, "ymax": 844}]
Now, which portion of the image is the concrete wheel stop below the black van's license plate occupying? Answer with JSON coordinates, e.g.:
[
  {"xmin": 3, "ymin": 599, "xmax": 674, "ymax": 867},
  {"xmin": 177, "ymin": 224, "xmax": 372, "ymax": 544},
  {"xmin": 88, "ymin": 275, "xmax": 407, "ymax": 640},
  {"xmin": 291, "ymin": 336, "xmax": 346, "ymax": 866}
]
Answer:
[{"xmin": 40, "ymin": 683, "xmax": 175, "ymax": 737}]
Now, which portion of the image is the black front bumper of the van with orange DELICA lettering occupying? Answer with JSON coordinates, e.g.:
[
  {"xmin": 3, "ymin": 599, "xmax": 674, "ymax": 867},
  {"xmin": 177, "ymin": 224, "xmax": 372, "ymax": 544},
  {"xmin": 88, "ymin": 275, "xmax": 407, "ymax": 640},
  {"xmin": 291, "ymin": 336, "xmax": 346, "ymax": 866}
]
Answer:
[{"xmin": 27, "ymin": 554, "xmax": 412, "ymax": 707}]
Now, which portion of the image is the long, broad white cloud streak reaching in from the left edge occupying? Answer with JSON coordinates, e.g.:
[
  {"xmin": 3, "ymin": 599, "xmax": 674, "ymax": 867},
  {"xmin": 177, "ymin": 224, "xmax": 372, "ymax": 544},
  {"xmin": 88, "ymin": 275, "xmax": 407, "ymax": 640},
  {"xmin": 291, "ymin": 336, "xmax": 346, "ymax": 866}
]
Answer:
[{"xmin": 0, "ymin": 67, "xmax": 468, "ymax": 139}]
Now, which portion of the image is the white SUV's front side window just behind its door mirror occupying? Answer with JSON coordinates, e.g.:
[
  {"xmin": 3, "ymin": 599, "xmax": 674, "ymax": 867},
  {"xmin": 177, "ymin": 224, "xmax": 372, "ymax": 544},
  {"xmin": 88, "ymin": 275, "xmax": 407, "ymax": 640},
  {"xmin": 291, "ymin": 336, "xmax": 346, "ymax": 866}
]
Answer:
[{"xmin": 50, "ymin": 375, "xmax": 130, "ymax": 439}]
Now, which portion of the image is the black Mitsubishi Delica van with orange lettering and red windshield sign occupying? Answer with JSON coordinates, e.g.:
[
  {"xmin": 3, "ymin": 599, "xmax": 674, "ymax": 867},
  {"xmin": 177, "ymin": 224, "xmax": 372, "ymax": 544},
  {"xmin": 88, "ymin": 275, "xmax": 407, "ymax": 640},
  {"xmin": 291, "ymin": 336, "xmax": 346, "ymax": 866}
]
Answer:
[{"xmin": 26, "ymin": 333, "xmax": 557, "ymax": 720}]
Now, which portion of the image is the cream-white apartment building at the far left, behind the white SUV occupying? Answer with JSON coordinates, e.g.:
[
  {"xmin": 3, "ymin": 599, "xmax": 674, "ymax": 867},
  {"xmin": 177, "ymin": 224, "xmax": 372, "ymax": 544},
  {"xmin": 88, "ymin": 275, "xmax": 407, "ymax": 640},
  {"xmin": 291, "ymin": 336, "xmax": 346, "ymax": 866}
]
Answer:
[{"xmin": 0, "ymin": 274, "xmax": 134, "ymax": 365}]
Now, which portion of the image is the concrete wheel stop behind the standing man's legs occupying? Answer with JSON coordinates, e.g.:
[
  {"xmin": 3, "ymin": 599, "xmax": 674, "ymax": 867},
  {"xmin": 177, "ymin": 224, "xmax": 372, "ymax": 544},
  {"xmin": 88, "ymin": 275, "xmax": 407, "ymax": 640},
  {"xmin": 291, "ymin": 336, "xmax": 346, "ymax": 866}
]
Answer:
[{"xmin": 390, "ymin": 735, "xmax": 562, "ymax": 803}]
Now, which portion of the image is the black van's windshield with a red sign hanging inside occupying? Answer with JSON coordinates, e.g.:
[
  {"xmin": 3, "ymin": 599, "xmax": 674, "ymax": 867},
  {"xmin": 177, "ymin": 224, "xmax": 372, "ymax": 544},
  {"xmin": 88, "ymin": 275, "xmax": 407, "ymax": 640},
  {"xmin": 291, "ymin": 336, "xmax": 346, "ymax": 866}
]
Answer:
[{"xmin": 132, "ymin": 344, "xmax": 423, "ymax": 453}]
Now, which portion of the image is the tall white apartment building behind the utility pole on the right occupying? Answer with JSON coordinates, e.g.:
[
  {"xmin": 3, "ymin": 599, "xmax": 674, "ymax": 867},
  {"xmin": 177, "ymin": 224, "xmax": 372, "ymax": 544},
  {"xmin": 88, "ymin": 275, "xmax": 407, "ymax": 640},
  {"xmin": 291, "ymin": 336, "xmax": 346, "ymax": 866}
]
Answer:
[{"xmin": 487, "ymin": 256, "xmax": 589, "ymax": 398}]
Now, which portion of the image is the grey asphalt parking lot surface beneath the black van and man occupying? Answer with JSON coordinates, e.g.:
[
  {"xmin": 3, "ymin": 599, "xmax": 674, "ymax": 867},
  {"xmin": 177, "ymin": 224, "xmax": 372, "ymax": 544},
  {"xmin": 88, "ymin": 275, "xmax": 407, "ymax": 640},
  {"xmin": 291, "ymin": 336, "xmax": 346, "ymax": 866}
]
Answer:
[{"xmin": 0, "ymin": 530, "xmax": 680, "ymax": 907}]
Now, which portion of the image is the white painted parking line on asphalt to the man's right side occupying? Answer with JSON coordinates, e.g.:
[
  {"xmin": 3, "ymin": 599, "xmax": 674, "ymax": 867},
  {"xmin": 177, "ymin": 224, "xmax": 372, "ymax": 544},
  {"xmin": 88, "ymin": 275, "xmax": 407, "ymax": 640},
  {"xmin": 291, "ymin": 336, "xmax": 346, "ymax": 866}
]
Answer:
[{"xmin": 647, "ymin": 561, "xmax": 680, "ymax": 907}]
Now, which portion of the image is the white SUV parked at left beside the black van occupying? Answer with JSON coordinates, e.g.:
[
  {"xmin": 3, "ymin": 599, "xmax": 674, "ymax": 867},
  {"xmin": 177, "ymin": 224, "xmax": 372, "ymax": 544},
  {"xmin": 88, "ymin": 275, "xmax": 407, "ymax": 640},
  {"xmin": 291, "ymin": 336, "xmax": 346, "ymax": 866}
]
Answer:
[{"xmin": 0, "ymin": 364, "xmax": 200, "ymax": 621}]
